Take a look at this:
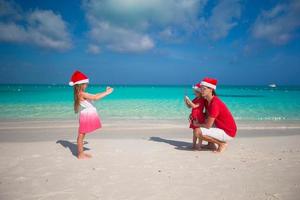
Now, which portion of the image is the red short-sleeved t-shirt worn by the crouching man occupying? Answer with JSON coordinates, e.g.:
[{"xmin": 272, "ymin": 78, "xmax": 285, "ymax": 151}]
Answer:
[{"xmin": 205, "ymin": 96, "xmax": 237, "ymax": 137}]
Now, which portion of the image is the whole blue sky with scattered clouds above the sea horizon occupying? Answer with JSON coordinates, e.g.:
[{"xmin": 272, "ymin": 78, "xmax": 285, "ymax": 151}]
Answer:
[{"xmin": 0, "ymin": 0, "xmax": 300, "ymax": 85}]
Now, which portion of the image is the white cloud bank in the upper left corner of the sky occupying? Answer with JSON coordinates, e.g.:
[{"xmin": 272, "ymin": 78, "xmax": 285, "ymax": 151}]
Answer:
[{"xmin": 0, "ymin": 1, "xmax": 72, "ymax": 50}]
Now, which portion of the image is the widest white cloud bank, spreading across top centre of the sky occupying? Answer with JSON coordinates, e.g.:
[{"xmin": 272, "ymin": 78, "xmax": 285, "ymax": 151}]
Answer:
[{"xmin": 82, "ymin": 0, "xmax": 246, "ymax": 52}]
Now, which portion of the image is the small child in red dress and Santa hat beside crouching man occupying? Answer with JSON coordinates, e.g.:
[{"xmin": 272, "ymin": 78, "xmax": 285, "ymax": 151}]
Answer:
[{"xmin": 184, "ymin": 83, "xmax": 205, "ymax": 150}]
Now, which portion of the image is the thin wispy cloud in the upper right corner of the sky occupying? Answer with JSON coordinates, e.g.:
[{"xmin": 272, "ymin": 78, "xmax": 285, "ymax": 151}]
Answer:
[{"xmin": 252, "ymin": 0, "xmax": 300, "ymax": 45}]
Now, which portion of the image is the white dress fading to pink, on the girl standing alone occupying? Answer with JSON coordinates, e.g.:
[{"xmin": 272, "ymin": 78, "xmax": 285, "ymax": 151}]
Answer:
[{"xmin": 79, "ymin": 100, "xmax": 101, "ymax": 134}]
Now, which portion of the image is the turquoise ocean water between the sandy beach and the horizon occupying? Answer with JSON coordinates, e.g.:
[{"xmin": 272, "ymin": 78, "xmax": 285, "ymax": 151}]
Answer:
[{"xmin": 0, "ymin": 85, "xmax": 300, "ymax": 120}]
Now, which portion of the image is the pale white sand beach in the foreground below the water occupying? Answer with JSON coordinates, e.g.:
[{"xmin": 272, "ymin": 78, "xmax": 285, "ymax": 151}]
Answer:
[{"xmin": 0, "ymin": 120, "xmax": 300, "ymax": 200}]
